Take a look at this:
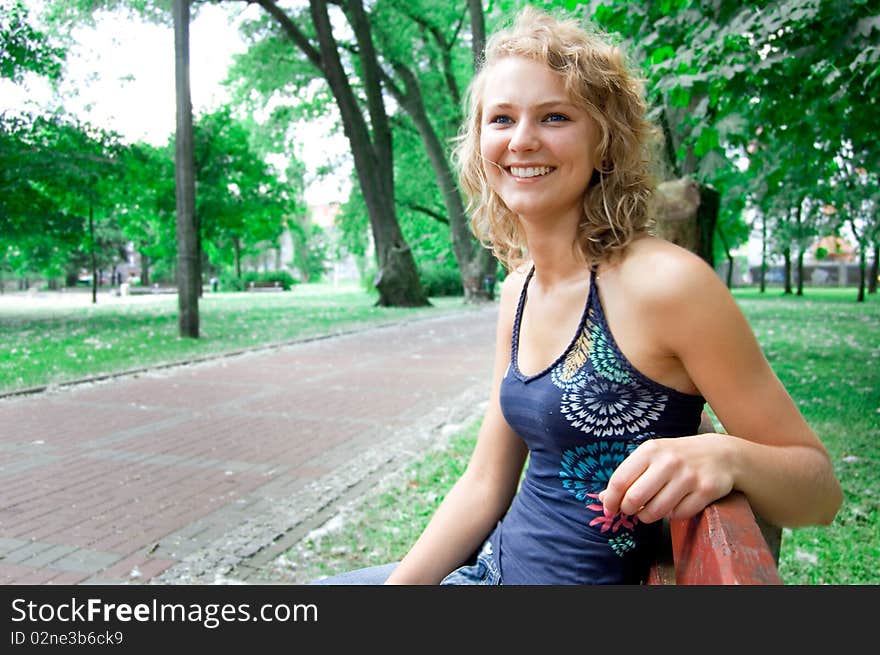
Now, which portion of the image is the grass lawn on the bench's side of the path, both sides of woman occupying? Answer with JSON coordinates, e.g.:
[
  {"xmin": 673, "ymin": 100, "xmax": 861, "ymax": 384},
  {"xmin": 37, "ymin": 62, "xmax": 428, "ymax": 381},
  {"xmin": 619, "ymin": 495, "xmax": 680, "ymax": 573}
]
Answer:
[{"xmin": 286, "ymin": 288, "xmax": 880, "ymax": 585}]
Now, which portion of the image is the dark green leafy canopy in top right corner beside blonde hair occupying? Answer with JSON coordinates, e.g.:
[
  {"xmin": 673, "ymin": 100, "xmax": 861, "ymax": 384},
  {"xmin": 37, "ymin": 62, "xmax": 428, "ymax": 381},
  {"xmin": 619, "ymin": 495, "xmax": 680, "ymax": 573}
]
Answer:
[{"xmin": 588, "ymin": 0, "xmax": 880, "ymax": 276}]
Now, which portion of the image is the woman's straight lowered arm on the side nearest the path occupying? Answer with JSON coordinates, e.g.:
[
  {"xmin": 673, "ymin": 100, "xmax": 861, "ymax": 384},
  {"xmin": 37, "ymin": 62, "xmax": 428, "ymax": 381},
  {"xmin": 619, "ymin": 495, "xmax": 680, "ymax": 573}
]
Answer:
[{"xmin": 386, "ymin": 273, "xmax": 527, "ymax": 584}]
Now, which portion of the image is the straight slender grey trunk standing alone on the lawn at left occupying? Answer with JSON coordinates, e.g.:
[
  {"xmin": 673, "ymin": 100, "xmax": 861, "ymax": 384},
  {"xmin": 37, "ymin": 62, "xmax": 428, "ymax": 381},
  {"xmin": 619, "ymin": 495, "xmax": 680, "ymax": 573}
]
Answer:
[{"xmin": 173, "ymin": 0, "xmax": 201, "ymax": 339}]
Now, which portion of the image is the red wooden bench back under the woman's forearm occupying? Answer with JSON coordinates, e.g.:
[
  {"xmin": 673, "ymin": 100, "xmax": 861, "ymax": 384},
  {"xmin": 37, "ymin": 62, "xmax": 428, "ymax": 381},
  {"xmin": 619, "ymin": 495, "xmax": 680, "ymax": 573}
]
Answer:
[{"xmin": 646, "ymin": 412, "xmax": 784, "ymax": 585}]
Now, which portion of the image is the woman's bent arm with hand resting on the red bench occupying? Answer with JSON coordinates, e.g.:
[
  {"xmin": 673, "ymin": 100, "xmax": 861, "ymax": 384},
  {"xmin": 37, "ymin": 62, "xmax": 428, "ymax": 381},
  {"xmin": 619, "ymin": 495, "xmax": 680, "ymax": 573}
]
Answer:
[{"xmin": 601, "ymin": 246, "xmax": 842, "ymax": 526}]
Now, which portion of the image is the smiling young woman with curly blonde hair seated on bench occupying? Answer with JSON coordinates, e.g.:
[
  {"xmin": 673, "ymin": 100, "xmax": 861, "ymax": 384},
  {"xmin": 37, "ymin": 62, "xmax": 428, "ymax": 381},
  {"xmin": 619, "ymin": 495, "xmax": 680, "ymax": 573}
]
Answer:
[{"xmin": 314, "ymin": 8, "xmax": 842, "ymax": 584}]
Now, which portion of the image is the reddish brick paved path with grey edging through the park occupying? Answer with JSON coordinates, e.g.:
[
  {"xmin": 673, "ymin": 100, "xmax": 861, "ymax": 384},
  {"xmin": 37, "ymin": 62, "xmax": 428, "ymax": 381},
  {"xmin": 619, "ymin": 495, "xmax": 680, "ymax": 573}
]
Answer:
[{"xmin": 0, "ymin": 307, "xmax": 497, "ymax": 585}]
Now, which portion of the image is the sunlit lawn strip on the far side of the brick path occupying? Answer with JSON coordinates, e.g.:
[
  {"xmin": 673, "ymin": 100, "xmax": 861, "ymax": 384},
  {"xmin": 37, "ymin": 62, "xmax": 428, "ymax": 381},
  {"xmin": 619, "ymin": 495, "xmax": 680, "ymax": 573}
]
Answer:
[{"xmin": 0, "ymin": 284, "xmax": 472, "ymax": 393}]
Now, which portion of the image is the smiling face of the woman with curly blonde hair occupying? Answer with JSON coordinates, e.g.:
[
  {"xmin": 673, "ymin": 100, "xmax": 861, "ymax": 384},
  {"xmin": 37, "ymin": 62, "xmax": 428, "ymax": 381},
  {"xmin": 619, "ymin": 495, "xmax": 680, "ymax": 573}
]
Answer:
[{"xmin": 480, "ymin": 57, "xmax": 599, "ymax": 231}]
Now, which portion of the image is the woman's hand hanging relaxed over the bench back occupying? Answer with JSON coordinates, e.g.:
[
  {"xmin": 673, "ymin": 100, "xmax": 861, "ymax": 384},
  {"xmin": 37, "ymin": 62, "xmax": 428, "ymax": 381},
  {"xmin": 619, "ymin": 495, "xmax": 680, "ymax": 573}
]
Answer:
[{"xmin": 599, "ymin": 433, "xmax": 734, "ymax": 523}]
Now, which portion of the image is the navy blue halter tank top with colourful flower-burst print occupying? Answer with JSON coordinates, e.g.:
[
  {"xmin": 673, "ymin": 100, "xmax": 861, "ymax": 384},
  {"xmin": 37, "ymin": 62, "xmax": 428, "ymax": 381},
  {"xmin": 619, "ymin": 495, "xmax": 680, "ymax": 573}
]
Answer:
[{"xmin": 489, "ymin": 267, "xmax": 705, "ymax": 585}]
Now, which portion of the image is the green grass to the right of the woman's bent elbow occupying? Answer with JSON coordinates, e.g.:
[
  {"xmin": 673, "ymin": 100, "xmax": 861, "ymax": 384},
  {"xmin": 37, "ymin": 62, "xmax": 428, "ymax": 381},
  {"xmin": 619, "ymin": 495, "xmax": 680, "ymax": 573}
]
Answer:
[{"xmin": 734, "ymin": 289, "xmax": 880, "ymax": 584}]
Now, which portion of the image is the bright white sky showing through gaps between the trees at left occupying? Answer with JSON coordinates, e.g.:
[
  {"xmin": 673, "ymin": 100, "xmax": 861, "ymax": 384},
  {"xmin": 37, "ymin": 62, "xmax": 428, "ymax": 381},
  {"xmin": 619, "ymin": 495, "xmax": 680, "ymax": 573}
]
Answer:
[{"xmin": 0, "ymin": 2, "xmax": 350, "ymax": 204}]
